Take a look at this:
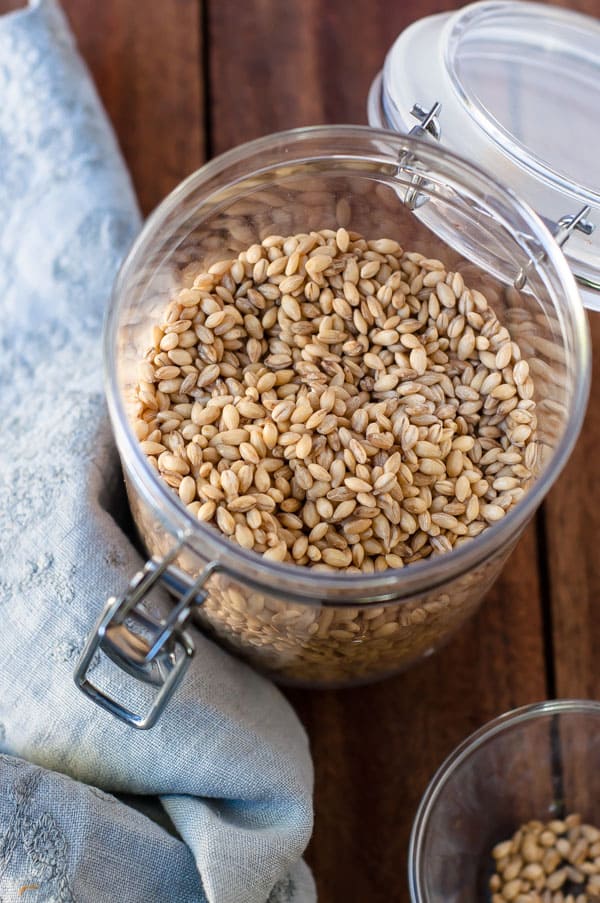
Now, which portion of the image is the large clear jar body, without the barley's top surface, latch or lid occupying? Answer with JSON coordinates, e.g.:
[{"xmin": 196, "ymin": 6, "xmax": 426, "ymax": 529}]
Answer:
[{"xmin": 105, "ymin": 126, "xmax": 590, "ymax": 686}]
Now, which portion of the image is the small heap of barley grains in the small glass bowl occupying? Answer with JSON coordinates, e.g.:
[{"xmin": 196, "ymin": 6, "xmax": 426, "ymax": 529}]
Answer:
[{"xmin": 490, "ymin": 813, "xmax": 600, "ymax": 903}]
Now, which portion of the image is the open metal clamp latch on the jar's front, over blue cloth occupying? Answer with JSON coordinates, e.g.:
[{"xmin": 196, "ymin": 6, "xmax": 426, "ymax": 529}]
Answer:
[{"xmin": 74, "ymin": 539, "xmax": 219, "ymax": 730}]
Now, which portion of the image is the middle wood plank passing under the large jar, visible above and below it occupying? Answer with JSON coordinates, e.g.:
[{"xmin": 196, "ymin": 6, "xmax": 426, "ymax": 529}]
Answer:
[{"xmin": 209, "ymin": 0, "xmax": 546, "ymax": 903}]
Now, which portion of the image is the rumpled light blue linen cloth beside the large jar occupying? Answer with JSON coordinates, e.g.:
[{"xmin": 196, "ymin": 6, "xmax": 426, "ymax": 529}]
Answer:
[{"xmin": 0, "ymin": 0, "xmax": 315, "ymax": 903}]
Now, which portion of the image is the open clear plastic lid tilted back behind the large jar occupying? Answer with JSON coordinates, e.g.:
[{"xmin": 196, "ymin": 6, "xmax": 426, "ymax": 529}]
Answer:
[{"xmin": 369, "ymin": 0, "xmax": 600, "ymax": 309}]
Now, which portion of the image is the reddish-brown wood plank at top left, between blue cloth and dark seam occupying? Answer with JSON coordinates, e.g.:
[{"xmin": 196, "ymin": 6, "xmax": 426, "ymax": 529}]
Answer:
[{"xmin": 63, "ymin": 0, "xmax": 205, "ymax": 213}]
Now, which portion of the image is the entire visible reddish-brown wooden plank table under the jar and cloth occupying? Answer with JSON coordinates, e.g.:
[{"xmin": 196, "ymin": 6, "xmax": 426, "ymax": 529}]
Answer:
[{"xmin": 0, "ymin": 0, "xmax": 600, "ymax": 903}]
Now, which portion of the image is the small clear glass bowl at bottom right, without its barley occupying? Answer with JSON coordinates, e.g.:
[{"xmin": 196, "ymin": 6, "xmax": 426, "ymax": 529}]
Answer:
[{"xmin": 409, "ymin": 699, "xmax": 600, "ymax": 903}]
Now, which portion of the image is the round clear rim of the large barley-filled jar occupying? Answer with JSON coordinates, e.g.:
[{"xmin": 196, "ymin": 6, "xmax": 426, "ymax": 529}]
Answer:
[{"xmin": 104, "ymin": 125, "xmax": 591, "ymax": 606}]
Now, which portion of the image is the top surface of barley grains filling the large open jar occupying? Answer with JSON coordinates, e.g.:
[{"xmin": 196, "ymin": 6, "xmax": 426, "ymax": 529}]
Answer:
[{"xmin": 135, "ymin": 229, "xmax": 536, "ymax": 572}]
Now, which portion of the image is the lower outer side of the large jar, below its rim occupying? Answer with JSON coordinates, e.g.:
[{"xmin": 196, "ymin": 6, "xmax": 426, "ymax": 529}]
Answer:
[{"xmin": 126, "ymin": 462, "xmax": 516, "ymax": 686}]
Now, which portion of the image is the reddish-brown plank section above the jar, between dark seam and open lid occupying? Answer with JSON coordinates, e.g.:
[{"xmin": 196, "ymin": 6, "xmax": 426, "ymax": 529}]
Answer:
[{"xmin": 208, "ymin": 0, "xmax": 456, "ymax": 153}]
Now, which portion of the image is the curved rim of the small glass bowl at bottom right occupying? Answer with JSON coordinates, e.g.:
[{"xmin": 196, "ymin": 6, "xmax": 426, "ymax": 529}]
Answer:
[{"xmin": 408, "ymin": 699, "xmax": 600, "ymax": 903}]
